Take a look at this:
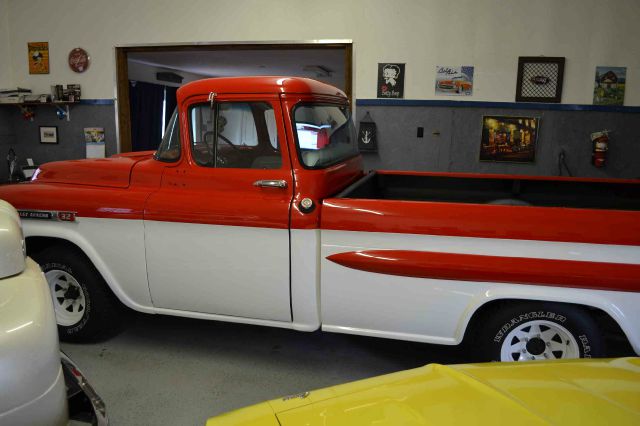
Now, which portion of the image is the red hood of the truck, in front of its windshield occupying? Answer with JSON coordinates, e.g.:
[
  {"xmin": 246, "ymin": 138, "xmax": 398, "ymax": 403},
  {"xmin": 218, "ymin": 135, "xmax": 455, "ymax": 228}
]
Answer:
[{"xmin": 32, "ymin": 151, "xmax": 153, "ymax": 188}]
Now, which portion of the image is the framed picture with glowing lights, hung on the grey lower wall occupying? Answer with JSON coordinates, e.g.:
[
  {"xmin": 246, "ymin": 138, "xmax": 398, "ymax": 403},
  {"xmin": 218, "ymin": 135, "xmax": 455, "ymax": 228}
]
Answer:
[{"xmin": 480, "ymin": 115, "xmax": 540, "ymax": 163}]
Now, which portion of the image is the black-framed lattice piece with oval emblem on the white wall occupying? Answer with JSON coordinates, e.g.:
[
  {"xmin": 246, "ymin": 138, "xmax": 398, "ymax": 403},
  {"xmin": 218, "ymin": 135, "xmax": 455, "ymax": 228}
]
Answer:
[{"xmin": 516, "ymin": 56, "xmax": 564, "ymax": 103}]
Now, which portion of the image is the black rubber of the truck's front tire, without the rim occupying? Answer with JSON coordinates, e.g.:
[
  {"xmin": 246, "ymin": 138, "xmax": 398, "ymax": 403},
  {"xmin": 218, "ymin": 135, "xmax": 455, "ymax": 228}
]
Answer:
[{"xmin": 32, "ymin": 245, "xmax": 125, "ymax": 342}]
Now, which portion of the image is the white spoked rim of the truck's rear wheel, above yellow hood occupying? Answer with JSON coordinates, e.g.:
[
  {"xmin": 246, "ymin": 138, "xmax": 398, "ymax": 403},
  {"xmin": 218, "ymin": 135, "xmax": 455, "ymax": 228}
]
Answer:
[{"xmin": 500, "ymin": 320, "xmax": 580, "ymax": 361}]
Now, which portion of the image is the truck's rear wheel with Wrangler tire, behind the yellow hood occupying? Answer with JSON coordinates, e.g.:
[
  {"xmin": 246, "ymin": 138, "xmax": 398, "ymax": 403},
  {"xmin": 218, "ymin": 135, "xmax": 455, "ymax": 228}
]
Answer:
[{"xmin": 476, "ymin": 302, "xmax": 606, "ymax": 361}]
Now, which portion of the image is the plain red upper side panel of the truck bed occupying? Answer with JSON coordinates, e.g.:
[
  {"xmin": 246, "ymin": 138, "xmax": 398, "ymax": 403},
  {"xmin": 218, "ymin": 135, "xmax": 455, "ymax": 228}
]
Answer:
[{"xmin": 322, "ymin": 198, "xmax": 640, "ymax": 245}]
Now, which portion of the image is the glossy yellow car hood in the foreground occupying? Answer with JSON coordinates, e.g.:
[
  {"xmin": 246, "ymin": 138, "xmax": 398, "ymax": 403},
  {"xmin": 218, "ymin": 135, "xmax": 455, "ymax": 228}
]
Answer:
[{"xmin": 207, "ymin": 358, "xmax": 640, "ymax": 426}]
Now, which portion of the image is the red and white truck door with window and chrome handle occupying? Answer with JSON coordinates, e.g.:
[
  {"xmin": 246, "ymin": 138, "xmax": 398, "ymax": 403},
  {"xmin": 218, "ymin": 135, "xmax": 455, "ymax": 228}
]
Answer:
[{"xmin": 145, "ymin": 95, "xmax": 293, "ymax": 321}]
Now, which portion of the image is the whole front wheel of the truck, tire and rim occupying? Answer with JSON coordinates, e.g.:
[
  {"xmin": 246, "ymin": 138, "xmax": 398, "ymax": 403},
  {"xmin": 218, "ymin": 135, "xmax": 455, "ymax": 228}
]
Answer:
[{"xmin": 33, "ymin": 246, "xmax": 123, "ymax": 341}]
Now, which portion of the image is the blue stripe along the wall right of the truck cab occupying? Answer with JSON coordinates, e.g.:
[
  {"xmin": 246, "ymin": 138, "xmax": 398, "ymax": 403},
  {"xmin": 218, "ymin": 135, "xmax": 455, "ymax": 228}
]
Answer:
[{"xmin": 356, "ymin": 99, "xmax": 640, "ymax": 113}]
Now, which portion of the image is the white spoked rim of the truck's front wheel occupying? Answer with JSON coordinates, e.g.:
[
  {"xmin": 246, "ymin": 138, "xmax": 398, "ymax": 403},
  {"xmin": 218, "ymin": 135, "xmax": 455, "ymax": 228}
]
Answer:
[{"xmin": 44, "ymin": 269, "xmax": 86, "ymax": 327}]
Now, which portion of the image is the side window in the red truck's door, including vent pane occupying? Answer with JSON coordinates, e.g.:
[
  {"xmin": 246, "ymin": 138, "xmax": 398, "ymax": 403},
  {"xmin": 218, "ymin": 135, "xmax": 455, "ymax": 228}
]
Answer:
[{"xmin": 189, "ymin": 102, "xmax": 282, "ymax": 169}]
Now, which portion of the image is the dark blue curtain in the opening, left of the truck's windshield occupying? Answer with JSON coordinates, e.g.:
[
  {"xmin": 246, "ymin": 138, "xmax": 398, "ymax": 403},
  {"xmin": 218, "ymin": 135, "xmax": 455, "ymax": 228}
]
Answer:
[{"xmin": 129, "ymin": 81, "xmax": 165, "ymax": 151}]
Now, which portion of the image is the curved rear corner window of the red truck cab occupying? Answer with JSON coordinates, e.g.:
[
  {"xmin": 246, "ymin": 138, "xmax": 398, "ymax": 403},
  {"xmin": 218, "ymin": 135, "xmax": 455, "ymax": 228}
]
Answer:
[{"xmin": 293, "ymin": 104, "xmax": 358, "ymax": 168}]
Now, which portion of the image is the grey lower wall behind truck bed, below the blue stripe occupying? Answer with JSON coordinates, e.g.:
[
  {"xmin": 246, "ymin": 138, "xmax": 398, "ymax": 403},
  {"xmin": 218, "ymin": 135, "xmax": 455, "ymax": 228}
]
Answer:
[{"xmin": 356, "ymin": 105, "xmax": 640, "ymax": 179}]
